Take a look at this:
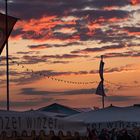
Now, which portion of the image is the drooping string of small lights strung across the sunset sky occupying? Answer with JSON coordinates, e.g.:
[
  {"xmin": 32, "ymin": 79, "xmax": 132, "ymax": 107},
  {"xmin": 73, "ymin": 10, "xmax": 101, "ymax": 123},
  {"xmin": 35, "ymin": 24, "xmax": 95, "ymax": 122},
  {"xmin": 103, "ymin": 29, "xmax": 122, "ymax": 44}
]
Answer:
[{"xmin": 9, "ymin": 58, "xmax": 140, "ymax": 89}]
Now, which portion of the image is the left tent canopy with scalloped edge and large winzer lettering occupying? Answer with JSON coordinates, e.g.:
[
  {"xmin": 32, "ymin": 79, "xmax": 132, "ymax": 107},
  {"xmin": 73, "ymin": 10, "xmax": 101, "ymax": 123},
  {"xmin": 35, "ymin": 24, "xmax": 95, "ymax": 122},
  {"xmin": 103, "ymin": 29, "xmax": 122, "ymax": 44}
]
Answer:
[{"xmin": 0, "ymin": 111, "xmax": 86, "ymax": 136}]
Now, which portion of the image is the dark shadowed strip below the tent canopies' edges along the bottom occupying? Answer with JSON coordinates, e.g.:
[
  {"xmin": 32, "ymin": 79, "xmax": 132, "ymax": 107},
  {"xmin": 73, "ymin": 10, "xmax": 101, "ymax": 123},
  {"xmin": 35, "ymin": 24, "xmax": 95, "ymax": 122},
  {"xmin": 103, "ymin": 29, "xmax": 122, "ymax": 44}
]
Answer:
[{"xmin": 0, "ymin": 128, "xmax": 140, "ymax": 140}]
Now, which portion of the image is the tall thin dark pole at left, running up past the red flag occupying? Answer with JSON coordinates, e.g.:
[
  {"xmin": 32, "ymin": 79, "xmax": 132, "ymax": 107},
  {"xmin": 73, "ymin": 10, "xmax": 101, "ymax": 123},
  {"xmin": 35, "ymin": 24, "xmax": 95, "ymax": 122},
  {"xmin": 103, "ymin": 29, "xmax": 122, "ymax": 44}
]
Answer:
[{"xmin": 5, "ymin": 0, "xmax": 10, "ymax": 111}]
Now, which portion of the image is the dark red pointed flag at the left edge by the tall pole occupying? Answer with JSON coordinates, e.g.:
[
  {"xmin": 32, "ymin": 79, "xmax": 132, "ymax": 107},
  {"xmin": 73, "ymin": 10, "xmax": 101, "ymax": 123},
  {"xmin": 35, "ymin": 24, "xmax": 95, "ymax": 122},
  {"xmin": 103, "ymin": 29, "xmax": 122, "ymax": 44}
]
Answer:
[{"xmin": 0, "ymin": 13, "xmax": 17, "ymax": 55}]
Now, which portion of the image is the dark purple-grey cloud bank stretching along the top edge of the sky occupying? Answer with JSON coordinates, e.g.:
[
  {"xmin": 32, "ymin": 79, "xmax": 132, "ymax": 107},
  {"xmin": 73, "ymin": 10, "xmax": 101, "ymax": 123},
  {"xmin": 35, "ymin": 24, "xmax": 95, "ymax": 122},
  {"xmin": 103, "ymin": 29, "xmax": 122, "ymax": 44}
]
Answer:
[{"xmin": 1, "ymin": 0, "xmax": 131, "ymax": 19}]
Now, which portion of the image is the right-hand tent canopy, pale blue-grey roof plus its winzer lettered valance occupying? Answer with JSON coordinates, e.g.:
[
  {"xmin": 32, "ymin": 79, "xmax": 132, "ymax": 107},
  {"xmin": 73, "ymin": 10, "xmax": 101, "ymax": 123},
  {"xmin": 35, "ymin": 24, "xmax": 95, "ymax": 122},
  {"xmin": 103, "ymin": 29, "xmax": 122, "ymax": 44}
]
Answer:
[{"xmin": 66, "ymin": 106, "xmax": 140, "ymax": 129}]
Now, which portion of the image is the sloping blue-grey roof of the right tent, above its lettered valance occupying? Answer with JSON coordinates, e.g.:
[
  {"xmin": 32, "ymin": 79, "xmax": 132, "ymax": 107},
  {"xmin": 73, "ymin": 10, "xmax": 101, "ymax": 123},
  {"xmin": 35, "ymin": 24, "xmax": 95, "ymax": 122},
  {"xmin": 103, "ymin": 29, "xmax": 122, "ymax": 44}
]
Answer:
[{"xmin": 66, "ymin": 106, "xmax": 140, "ymax": 123}]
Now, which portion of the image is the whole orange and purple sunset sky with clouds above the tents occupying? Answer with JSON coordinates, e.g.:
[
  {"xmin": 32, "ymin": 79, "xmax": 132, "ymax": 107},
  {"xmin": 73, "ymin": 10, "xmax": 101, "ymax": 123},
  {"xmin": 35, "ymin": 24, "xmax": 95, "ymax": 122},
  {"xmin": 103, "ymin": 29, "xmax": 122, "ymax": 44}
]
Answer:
[{"xmin": 0, "ymin": 0, "xmax": 140, "ymax": 110}]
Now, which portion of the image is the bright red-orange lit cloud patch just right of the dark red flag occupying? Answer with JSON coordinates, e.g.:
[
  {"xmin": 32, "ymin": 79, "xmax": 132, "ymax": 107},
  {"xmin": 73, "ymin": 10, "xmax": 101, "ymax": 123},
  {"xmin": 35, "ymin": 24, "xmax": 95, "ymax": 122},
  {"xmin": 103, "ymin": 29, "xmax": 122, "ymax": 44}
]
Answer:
[{"xmin": 12, "ymin": 15, "xmax": 76, "ymax": 41}]
